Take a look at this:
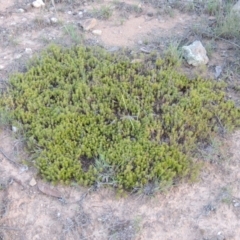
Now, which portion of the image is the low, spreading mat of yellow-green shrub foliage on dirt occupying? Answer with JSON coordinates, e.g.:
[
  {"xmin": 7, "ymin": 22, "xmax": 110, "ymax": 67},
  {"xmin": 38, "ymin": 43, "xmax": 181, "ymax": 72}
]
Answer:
[{"xmin": 1, "ymin": 46, "xmax": 240, "ymax": 189}]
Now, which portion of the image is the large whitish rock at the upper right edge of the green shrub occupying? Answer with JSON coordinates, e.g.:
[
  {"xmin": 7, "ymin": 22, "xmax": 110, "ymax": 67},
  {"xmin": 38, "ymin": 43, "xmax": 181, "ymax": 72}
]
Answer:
[{"xmin": 182, "ymin": 41, "xmax": 209, "ymax": 67}]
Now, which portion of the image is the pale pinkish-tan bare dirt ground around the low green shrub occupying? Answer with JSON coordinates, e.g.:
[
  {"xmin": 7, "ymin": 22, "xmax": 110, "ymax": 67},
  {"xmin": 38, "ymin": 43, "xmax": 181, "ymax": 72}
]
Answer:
[{"xmin": 0, "ymin": 0, "xmax": 240, "ymax": 240}]
